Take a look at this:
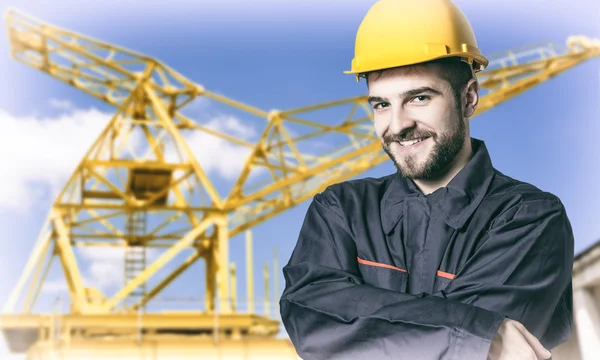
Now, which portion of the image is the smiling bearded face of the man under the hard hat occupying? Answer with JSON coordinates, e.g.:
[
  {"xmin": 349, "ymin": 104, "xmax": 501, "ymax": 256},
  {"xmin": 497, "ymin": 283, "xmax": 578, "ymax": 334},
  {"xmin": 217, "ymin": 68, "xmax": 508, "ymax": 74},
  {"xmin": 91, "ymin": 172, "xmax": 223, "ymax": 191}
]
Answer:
[{"xmin": 369, "ymin": 64, "xmax": 468, "ymax": 180}]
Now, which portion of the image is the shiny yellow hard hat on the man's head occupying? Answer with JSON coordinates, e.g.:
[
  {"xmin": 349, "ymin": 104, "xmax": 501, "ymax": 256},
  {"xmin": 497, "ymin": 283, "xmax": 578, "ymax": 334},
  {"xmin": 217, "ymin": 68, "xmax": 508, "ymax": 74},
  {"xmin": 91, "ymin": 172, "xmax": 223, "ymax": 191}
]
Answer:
[{"xmin": 344, "ymin": 0, "xmax": 488, "ymax": 81}]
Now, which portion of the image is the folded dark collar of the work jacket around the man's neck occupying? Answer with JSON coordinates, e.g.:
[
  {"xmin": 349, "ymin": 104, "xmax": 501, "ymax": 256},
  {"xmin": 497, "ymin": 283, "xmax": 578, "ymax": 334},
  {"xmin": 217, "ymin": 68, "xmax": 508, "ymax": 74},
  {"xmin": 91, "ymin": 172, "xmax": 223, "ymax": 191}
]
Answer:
[{"xmin": 380, "ymin": 138, "xmax": 495, "ymax": 234}]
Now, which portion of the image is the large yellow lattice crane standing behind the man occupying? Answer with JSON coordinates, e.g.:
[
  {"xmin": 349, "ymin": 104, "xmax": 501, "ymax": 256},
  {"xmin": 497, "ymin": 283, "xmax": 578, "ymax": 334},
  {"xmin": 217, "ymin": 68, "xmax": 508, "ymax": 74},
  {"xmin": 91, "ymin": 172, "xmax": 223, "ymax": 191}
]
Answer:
[{"xmin": 0, "ymin": 10, "xmax": 600, "ymax": 359}]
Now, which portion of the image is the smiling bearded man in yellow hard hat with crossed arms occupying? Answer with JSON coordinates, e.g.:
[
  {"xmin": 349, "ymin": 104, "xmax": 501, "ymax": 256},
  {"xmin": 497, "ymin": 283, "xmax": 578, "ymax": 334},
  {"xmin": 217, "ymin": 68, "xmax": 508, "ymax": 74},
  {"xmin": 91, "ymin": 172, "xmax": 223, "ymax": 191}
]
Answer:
[{"xmin": 280, "ymin": 0, "xmax": 573, "ymax": 360}]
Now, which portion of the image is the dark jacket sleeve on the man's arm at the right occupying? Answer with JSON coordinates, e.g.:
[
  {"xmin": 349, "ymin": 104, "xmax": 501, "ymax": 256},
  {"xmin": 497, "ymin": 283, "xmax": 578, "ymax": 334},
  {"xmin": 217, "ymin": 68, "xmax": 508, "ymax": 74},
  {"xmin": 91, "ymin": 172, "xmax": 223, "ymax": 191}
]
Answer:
[{"xmin": 435, "ymin": 197, "xmax": 574, "ymax": 349}]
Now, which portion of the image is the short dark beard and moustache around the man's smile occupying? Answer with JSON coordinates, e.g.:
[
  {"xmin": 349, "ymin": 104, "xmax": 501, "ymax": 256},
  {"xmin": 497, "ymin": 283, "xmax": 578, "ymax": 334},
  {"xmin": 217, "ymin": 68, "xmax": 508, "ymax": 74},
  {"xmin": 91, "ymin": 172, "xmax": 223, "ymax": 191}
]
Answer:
[{"xmin": 382, "ymin": 113, "xmax": 467, "ymax": 180}]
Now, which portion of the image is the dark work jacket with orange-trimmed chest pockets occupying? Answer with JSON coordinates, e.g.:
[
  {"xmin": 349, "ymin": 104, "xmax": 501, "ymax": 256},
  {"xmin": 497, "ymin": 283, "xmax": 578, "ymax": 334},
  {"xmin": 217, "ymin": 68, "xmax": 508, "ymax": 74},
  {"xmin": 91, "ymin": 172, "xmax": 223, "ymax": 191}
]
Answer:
[{"xmin": 280, "ymin": 139, "xmax": 573, "ymax": 360}]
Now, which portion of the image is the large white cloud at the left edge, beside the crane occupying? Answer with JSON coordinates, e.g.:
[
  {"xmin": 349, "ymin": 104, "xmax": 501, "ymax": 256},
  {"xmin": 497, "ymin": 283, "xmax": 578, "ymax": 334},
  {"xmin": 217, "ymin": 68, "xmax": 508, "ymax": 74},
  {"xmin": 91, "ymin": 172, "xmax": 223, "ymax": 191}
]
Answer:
[{"xmin": 0, "ymin": 108, "xmax": 112, "ymax": 211}]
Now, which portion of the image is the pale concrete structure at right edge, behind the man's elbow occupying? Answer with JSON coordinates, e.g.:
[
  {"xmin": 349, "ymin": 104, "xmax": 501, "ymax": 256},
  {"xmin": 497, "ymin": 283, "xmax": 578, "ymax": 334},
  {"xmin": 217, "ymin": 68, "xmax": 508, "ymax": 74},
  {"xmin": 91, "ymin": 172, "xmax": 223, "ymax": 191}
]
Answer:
[{"xmin": 552, "ymin": 241, "xmax": 600, "ymax": 360}]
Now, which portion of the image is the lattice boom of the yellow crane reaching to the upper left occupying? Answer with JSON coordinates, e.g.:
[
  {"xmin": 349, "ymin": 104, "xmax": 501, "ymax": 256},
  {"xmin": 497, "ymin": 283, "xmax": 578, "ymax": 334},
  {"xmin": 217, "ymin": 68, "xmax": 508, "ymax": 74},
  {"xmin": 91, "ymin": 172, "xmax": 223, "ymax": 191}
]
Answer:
[{"xmin": 6, "ymin": 9, "xmax": 198, "ymax": 110}]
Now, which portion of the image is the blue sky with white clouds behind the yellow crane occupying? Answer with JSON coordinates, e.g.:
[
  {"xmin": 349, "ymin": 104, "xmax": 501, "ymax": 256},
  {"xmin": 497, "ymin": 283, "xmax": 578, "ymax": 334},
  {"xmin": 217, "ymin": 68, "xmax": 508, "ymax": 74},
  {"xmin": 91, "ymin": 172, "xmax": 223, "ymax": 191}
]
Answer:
[{"xmin": 0, "ymin": 0, "xmax": 600, "ymax": 358}]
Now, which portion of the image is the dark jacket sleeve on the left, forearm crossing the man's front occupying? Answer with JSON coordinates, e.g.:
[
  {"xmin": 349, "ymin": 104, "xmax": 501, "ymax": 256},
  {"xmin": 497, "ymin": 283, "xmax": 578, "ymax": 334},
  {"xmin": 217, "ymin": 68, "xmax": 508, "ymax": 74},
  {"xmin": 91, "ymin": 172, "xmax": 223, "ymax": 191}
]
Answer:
[{"xmin": 280, "ymin": 192, "xmax": 504, "ymax": 360}]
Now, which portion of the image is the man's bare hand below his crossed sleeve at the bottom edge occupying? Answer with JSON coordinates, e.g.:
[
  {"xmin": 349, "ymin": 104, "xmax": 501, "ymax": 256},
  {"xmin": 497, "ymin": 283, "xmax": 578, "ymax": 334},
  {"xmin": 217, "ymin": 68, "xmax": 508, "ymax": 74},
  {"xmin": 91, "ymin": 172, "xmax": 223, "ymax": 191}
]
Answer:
[{"xmin": 488, "ymin": 319, "xmax": 552, "ymax": 360}]
